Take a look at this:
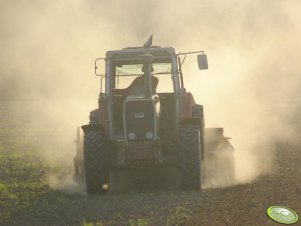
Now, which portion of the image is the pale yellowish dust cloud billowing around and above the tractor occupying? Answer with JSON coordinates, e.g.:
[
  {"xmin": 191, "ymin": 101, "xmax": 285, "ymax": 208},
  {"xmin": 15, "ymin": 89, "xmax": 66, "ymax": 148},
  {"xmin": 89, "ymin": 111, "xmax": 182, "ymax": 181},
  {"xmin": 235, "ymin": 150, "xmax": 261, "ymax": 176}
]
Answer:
[{"xmin": 0, "ymin": 0, "xmax": 301, "ymax": 189}]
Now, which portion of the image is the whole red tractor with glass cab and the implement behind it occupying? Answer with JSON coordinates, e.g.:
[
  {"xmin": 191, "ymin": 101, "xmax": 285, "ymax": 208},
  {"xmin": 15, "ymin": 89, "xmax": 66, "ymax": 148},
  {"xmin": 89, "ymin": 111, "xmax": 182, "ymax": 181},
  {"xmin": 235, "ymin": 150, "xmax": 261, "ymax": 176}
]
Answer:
[{"xmin": 74, "ymin": 36, "xmax": 235, "ymax": 195}]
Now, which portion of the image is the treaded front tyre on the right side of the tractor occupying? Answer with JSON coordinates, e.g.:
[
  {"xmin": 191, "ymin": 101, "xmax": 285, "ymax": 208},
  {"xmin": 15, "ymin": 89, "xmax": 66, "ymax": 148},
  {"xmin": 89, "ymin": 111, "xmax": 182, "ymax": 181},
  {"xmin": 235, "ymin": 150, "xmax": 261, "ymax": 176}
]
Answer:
[{"xmin": 178, "ymin": 125, "xmax": 201, "ymax": 190}]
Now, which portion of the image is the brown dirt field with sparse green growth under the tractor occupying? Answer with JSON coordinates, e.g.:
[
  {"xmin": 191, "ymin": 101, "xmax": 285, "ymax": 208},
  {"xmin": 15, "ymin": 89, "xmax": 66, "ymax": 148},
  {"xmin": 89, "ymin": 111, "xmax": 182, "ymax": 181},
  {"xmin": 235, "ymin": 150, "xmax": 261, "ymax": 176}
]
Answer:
[{"xmin": 0, "ymin": 103, "xmax": 301, "ymax": 226}]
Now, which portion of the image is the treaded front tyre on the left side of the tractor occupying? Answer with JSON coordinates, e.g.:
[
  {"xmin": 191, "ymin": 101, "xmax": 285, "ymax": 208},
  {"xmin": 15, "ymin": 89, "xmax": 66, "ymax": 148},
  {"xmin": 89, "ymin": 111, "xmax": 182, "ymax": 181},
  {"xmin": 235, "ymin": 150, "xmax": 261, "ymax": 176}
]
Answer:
[{"xmin": 84, "ymin": 111, "xmax": 109, "ymax": 195}]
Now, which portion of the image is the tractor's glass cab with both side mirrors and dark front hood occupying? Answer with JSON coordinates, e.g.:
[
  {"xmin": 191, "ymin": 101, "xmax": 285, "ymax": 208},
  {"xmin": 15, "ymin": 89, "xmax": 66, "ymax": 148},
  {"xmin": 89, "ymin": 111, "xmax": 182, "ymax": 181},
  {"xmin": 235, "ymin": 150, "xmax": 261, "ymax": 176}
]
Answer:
[{"xmin": 96, "ymin": 37, "xmax": 208, "ymax": 142}]
